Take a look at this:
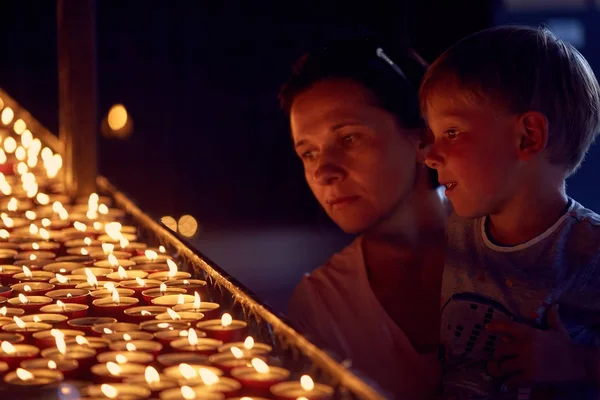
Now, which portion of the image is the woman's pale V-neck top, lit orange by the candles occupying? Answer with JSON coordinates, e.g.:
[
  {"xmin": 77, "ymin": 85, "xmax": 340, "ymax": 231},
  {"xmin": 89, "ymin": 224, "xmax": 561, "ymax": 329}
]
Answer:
[{"xmin": 289, "ymin": 236, "xmax": 440, "ymax": 399}]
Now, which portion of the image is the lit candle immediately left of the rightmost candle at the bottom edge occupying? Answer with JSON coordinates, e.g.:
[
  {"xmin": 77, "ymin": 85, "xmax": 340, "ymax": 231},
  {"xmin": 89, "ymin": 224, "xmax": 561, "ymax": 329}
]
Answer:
[{"xmin": 231, "ymin": 358, "xmax": 290, "ymax": 397}]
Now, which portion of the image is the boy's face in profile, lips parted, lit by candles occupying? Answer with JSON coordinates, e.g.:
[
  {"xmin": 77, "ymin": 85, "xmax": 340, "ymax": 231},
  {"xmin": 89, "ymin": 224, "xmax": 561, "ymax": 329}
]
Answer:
[{"xmin": 425, "ymin": 91, "xmax": 520, "ymax": 218}]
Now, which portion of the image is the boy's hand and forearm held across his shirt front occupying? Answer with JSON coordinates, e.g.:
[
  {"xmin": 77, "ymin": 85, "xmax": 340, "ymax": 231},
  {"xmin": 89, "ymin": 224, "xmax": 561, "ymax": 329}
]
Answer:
[{"xmin": 486, "ymin": 306, "xmax": 598, "ymax": 387}]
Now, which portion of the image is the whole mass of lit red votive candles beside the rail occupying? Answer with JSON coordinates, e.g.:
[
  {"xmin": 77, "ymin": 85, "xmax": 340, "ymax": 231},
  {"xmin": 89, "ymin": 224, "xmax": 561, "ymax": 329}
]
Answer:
[{"xmin": 0, "ymin": 117, "xmax": 334, "ymax": 400}]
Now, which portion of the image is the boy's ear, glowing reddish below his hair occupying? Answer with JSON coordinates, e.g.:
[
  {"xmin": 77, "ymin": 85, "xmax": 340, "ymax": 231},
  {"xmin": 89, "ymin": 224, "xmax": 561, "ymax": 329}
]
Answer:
[{"xmin": 518, "ymin": 111, "xmax": 548, "ymax": 160}]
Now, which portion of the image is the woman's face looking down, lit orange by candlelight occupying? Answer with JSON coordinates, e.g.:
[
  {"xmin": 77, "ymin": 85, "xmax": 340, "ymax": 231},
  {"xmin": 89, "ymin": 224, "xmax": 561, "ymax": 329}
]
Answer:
[{"xmin": 290, "ymin": 80, "xmax": 419, "ymax": 233}]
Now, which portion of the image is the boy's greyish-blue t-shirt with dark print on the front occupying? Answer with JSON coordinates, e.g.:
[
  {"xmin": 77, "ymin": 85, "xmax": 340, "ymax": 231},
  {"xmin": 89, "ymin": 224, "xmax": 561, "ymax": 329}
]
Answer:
[{"xmin": 441, "ymin": 199, "xmax": 600, "ymax": 400}]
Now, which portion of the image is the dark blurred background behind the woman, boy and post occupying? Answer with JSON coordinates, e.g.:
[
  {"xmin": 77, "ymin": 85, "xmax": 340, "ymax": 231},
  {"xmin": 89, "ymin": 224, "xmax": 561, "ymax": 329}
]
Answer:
[{"xmin": 0, "ymin": 0, "xmax": 600, "ymax": 309}]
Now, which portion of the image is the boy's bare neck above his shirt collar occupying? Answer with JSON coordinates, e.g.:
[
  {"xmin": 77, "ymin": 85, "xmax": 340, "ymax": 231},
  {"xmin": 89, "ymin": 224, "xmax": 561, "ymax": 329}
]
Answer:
[{"xmin": 487, "ymin": 181, "xmax": 568, "ymax": 246}]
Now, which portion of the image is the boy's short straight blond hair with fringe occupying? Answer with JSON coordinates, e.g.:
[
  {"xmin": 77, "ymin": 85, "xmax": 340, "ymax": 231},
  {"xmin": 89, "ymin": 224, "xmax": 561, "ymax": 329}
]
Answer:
[{"xmin": 419, "ymin": 26, "xmax": 600, "ymax": 175}]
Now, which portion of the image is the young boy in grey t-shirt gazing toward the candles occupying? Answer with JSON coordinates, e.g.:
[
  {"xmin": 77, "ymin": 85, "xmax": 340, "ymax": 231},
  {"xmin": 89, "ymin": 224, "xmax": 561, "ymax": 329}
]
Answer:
[{"xmin": 420, "ymin": 27, "xmax": 600, "ymax": 400}]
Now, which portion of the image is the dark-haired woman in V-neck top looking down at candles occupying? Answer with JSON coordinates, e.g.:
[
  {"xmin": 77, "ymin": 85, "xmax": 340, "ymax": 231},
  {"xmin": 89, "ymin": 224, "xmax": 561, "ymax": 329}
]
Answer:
[{"xmin": 280, "ymin": 38, "xmax": 447, "ymax": 399}]
